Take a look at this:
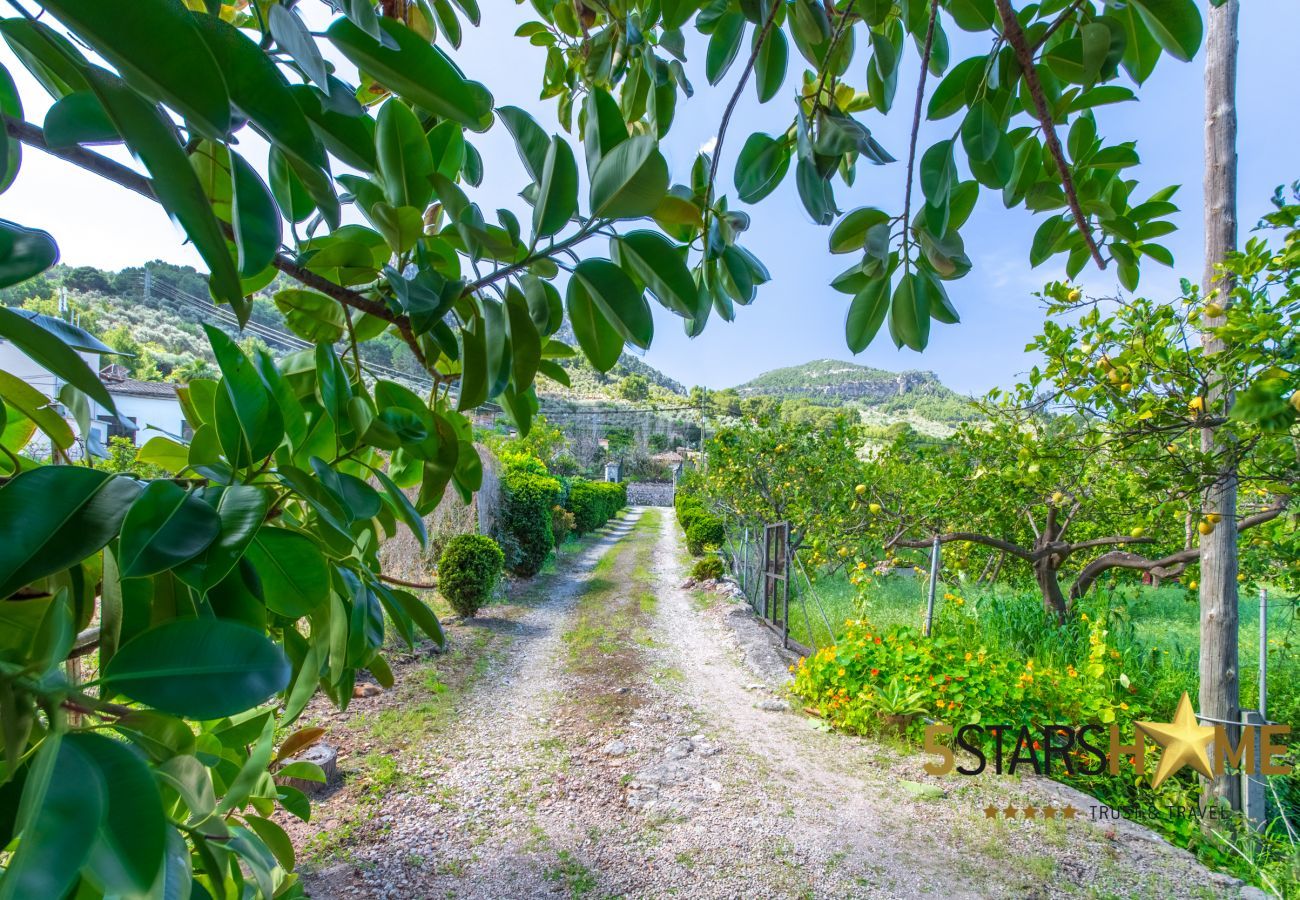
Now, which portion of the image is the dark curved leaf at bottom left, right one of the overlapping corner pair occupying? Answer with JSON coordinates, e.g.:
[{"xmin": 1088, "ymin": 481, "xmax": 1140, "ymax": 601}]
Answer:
[{"xmin": 76, "ymin": 732, "xmax": 166, "ymax": 895}]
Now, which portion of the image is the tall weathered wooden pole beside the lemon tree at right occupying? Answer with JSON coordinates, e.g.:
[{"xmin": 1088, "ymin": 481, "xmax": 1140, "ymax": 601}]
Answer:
[{"xmin": 1200, "ymin": 0, "xmax": 1242, "ymax": 809}]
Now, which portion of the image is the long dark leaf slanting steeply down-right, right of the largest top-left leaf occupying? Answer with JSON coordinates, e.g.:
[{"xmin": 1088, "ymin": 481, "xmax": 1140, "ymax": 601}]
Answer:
[{"xmin": 195, "ymin": 16, "xmax": 328, "ymax": 168}]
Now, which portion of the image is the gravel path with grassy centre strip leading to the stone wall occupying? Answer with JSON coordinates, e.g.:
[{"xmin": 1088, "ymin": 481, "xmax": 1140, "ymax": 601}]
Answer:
[{"xmin": 297, "ymin": 510, "xmax": 1258, "ymax": 899}]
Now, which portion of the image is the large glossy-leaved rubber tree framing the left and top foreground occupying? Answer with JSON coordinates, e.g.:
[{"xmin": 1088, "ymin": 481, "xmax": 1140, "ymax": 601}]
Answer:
[{"xmin": 0, "ymin": 0, "xmax": 1201, "ymax": 896}]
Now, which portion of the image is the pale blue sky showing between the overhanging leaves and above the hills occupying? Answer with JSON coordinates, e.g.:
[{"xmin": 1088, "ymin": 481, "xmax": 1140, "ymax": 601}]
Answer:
[{"xmin": 0, "ymin": 0, "xmax": 1300, "ymax": 393}]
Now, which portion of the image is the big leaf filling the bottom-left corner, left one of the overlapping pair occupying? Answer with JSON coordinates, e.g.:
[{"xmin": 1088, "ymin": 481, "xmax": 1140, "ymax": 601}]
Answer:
[{"xmin": 0, "ymin": 735, "xmax": 108, "ymax": 900}]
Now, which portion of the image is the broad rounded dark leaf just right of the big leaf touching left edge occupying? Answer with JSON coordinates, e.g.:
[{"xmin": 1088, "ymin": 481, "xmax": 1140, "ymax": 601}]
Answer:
[{"xmin": 117, "ymin": 481, "xmax": 221, "ymax": 577}]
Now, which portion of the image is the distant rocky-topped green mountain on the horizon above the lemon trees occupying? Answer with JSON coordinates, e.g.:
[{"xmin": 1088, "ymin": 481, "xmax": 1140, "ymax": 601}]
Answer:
[{"xmin": 736, "ymin": 359, "xmax": 975, "ymax": 424}]
